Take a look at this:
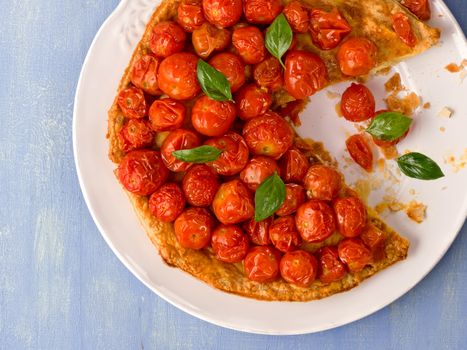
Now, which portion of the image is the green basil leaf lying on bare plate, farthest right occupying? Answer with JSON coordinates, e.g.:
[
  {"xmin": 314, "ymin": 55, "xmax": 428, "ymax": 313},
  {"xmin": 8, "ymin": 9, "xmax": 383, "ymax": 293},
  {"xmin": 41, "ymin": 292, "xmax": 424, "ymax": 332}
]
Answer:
[{"xmin": 397, "ymin": 152, "xmax": 444, "ymax": 180}]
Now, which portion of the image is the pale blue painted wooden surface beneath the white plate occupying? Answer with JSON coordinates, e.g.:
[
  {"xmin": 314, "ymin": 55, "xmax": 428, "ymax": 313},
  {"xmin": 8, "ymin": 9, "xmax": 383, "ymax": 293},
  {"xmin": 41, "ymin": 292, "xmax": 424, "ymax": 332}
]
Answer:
[{"xmin": 0, "ymin": 0, "xmax": 467, "ymax": 350}]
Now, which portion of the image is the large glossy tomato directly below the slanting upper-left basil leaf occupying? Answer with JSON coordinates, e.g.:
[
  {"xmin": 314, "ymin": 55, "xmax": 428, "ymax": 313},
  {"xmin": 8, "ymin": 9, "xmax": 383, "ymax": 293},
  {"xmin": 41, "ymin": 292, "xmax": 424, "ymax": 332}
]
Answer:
[{"xmin": 191, "ymin": 95, "xmax": 236, "ymax": 136}]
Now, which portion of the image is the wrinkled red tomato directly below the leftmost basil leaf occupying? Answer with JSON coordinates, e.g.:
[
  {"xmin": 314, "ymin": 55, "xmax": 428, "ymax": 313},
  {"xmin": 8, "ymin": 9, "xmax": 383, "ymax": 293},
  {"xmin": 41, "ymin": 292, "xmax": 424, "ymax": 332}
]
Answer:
[{"xmin": 182, "ymin": 164, "xmax": 220, "ymax": 207}]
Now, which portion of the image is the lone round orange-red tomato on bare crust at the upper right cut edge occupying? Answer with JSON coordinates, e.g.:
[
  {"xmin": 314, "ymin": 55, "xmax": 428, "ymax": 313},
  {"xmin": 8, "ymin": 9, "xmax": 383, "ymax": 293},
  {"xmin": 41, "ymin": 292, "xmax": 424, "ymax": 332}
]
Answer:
[{"xmin": 337, "ymin": 37, "xmax": 378, "ymax": 77}]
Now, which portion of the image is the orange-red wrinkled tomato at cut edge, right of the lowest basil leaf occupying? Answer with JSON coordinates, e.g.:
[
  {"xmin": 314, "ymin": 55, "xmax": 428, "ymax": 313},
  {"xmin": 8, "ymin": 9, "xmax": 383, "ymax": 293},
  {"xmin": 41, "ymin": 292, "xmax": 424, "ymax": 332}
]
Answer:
[{"xmin": 304, "ymin": 164, "xmax": 342, "ymax": 201}]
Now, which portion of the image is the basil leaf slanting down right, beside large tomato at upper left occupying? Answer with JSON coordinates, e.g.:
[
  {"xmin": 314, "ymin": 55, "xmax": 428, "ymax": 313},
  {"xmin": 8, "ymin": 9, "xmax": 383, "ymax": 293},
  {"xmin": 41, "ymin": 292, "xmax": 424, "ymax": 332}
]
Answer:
[{"xmin": 196, "ymin": 60, "xmax": 233, "ymax": 101}]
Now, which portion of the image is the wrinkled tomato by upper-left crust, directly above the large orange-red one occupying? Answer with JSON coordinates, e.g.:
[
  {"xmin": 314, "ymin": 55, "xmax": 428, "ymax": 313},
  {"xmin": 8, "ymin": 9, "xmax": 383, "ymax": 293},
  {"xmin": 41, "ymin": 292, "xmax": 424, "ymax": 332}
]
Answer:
[{"xmin": 149, "ymin": 21, "xmax": 186, "ymax": 57}]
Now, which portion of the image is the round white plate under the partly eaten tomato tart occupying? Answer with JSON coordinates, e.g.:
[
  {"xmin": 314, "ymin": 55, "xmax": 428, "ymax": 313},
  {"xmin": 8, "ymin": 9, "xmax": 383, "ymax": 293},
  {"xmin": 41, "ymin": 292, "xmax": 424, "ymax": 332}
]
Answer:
[{"xmin": 73, "ymin": 0, "xmax": 467, "ymax": 334}]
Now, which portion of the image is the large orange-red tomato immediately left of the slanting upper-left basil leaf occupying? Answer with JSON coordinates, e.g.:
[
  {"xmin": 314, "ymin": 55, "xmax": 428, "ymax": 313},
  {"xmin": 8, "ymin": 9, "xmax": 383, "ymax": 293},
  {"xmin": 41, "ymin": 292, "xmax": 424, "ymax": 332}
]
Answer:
[{"xmin": 157, "ymin": 52, "xmax": 201, "ymax": 100}]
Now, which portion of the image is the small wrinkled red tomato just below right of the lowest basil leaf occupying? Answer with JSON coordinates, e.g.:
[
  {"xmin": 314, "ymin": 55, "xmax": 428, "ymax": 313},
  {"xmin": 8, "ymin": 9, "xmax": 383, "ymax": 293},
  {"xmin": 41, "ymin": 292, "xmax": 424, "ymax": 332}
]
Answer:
[{"xmin": 269, "ymin": 215, "xmax": 302, "ymax": 253}]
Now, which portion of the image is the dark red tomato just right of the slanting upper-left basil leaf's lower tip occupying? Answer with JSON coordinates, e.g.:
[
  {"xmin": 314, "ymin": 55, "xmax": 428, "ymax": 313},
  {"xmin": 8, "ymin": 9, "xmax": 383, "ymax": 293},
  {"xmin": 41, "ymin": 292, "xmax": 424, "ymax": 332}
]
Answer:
[{"xmin": 235, "ymin": 84, "xmax": 272, "ymax": 120}]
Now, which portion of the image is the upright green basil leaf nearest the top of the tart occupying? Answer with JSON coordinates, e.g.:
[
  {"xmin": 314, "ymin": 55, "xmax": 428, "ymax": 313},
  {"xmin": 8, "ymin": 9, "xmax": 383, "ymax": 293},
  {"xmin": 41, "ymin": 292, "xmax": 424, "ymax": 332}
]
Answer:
[{"xmin": 265, "ymin": 13, "xmax": 293, "ymax": 68}]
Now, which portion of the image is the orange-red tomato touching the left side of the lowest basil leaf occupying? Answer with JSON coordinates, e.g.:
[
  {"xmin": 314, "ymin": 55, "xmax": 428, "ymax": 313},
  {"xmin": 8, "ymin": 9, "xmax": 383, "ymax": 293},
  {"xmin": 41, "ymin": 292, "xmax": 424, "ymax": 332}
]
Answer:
[{"xmin": 212, "ymin": 180, "xmax": 255, "ymax": 225}]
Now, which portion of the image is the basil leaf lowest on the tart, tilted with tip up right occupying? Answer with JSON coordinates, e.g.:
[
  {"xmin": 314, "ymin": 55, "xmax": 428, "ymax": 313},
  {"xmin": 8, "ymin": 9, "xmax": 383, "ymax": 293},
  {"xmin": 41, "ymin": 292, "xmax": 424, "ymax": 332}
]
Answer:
[{"xmin": 255, "ymin": 172, "xmax": 285, "ymax": 222}]
